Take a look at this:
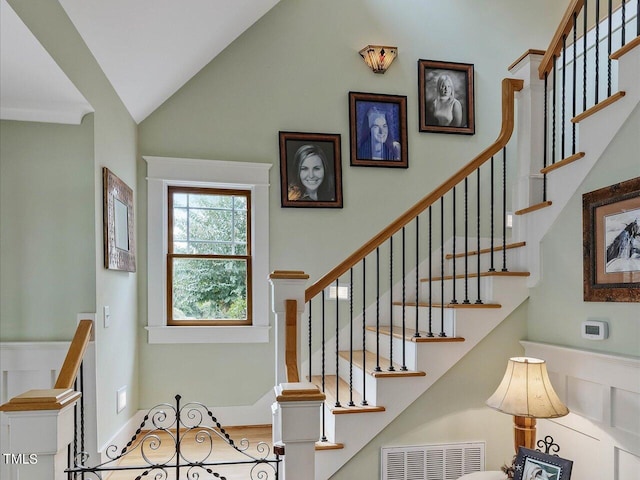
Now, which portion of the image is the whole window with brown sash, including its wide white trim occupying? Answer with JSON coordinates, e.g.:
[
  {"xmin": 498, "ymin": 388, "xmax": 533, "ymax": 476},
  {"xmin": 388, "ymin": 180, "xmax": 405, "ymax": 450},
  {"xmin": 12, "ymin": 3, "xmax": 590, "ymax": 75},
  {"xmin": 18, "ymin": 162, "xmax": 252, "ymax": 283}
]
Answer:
[{"xmin": 143, "ymin": 156, "xmax": 271, "ymax": 343}]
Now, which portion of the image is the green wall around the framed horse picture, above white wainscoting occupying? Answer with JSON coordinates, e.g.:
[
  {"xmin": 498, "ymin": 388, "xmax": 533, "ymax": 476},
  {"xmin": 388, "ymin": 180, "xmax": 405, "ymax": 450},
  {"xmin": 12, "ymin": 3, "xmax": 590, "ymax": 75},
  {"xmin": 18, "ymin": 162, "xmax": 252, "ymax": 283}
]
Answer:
[{"xmin": 527, "ymin": 107, "xmax": 640, "ymax": 356}]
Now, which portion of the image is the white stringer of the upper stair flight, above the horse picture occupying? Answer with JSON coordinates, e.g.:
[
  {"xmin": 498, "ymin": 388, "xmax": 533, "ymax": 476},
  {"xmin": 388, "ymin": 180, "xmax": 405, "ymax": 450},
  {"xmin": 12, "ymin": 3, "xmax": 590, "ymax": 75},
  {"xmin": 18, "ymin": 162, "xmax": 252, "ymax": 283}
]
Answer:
[{"xmin": 516, "ymin": 41, "xmax": 640, "ymax": 287}]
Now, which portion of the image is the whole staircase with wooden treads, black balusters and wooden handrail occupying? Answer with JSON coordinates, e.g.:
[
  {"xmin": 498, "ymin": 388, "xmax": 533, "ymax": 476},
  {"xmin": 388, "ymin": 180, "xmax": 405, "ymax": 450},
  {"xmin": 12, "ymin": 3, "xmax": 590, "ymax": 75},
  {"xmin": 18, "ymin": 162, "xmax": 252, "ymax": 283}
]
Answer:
[{"xmin": 276, "ymin": 2, "xmax": 640, "ymax": 479}]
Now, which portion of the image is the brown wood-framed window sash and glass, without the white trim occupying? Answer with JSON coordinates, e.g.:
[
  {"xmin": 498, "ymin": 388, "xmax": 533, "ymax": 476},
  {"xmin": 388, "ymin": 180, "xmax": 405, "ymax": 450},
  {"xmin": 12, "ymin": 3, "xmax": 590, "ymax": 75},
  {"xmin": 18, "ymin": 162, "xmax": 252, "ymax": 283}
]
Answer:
[{"xmin": 167, "ymin": 187, "xmax": 251, "ymax": 325}]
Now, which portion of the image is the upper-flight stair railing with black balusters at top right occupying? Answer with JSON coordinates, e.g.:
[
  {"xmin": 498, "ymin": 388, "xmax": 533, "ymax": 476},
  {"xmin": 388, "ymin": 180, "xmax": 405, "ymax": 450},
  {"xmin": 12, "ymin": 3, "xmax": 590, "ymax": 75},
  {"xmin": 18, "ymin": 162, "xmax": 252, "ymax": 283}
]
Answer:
[{"xmin": 539, "ymin": 0, "xmax": 640, "ymax": 201}]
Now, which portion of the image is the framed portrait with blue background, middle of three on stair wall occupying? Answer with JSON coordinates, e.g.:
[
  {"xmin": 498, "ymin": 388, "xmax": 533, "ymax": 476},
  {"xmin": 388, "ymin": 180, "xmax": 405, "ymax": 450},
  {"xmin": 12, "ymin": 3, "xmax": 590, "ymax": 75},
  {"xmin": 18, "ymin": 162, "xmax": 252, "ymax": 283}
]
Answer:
[{"xmin": 349, "ymin": 92, "xmax": 409, "ymax": 168}]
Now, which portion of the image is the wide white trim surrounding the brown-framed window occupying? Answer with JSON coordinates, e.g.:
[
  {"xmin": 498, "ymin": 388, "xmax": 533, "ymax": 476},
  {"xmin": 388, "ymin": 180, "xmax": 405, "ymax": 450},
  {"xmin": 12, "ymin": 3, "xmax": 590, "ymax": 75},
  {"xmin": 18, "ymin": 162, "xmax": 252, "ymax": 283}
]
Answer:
[{"xmin": 142, "ymin": 156, "xmax": 271, "ymax": 343}]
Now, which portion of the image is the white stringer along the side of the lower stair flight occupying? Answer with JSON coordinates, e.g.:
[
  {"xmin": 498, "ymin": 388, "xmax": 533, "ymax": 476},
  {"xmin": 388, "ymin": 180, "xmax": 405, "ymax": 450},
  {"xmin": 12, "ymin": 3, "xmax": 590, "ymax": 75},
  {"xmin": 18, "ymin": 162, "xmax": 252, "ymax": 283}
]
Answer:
[{"xmin": 315, "ymin": 277, "xmax": 529, "ymax": 480}]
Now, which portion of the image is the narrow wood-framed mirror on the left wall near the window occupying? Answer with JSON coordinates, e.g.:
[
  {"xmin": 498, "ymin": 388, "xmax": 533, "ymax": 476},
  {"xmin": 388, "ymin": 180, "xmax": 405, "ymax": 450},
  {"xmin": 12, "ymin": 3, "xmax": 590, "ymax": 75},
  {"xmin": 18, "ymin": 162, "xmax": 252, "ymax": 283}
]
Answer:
[{"xmin": 102, "ymin": 167, "xmax": 136, "ymax": 272}]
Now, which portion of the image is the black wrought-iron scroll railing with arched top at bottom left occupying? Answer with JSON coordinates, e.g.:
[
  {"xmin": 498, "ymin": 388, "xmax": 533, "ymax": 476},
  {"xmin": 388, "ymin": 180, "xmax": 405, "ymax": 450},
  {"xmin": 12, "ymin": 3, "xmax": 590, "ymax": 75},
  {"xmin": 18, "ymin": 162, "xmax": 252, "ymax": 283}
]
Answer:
[{"xmin": 65, "ymin": 395, "xmax": 281, "ymax": 480}]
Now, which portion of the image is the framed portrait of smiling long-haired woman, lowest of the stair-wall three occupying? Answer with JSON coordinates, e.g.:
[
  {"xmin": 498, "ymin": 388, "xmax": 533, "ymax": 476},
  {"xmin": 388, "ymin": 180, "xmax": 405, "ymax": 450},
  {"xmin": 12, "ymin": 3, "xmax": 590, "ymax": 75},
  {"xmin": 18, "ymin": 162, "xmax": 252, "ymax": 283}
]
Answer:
[{"xmin": 280, "ymin": 132, "xmax": 342, "ymax": 208}]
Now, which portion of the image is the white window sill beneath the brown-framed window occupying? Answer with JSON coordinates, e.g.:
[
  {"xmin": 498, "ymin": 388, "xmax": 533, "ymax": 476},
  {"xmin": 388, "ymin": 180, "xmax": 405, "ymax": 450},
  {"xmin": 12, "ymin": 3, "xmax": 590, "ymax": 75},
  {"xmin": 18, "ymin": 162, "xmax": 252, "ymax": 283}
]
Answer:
[{"xmin": 145, "ymin": 326, "xmax": 271, "ymax": 344}]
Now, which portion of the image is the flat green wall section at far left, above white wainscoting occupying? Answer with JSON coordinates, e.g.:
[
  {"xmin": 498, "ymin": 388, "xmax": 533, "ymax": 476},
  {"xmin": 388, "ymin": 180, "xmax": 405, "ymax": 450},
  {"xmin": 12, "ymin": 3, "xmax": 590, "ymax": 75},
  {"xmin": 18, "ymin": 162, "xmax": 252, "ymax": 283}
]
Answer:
[{"xmin": 0, "ymin": 115, "xmax": 96, "ymax": 341}]
